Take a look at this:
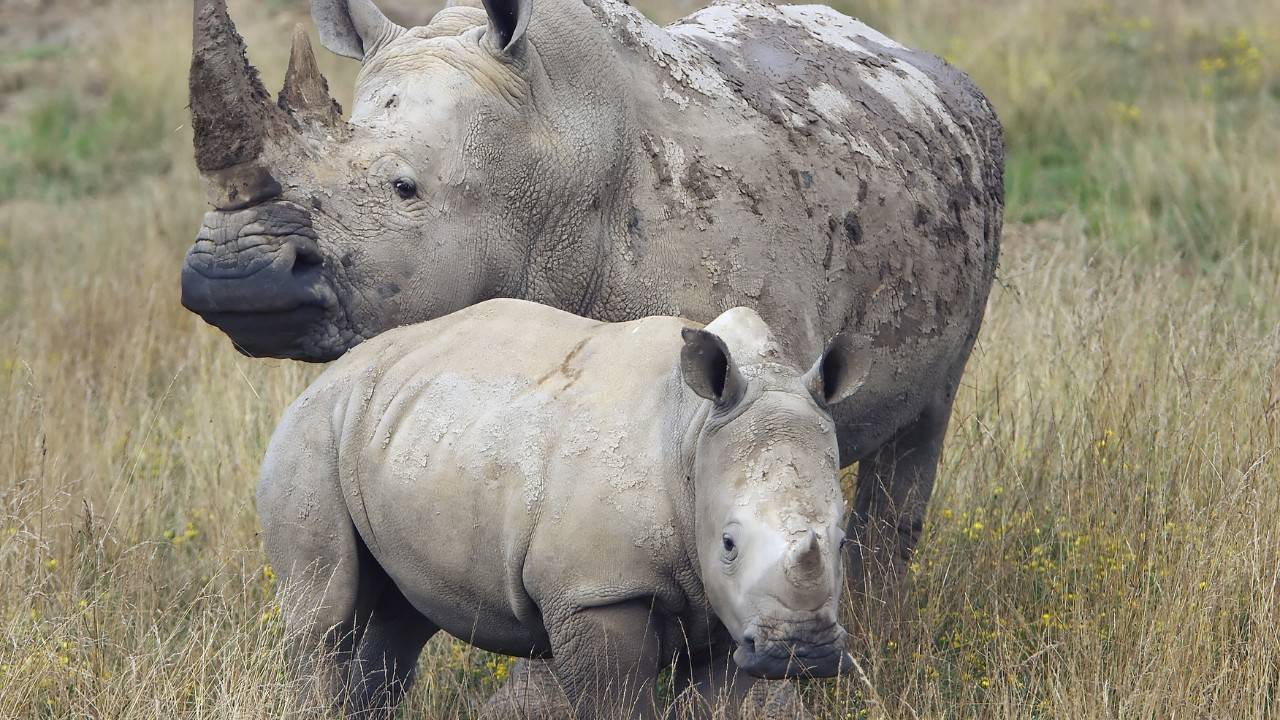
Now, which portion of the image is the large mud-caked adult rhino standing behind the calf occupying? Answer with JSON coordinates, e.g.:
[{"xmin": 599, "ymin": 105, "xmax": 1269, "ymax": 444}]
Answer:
[{"xmin": 182, "ymin": 0, "xmax": 1004, "ymax": 632}]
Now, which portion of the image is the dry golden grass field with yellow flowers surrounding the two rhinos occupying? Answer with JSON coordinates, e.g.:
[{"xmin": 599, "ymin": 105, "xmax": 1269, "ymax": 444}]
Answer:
[{"xmin": 0, "ymin": 0, "xmax": 1280, "ymax": 720}]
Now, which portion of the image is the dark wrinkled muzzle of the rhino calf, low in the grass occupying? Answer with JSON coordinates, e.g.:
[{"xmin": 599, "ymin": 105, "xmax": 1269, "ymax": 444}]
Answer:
[{"xmin": 733, "ymin": 621, "xmax": 854, "ymax": 680}]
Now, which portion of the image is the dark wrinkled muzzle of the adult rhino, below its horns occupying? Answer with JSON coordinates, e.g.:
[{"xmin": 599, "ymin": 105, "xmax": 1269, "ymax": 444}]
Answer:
[{"xmin": 182, "ymin": 201, "xmax": 342, "ymax": 361}]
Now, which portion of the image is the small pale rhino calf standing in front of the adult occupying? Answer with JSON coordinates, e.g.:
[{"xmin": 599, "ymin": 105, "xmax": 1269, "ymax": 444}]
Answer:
[{"xmin": 259, "ymin": 300, "xmax": 868, "ymax": 717}]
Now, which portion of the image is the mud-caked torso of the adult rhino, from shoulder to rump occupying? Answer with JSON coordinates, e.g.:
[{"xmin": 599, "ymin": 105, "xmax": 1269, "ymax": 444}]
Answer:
[{"xmin": 591, "ymin": 0, "xmax": 1004, "ymax": 462}]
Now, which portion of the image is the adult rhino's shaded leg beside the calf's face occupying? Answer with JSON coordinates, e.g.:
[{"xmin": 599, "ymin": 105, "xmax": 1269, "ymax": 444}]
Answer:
[{"xmin": 845, "ymin": 393, "xmax": 951, "ymax": 627}]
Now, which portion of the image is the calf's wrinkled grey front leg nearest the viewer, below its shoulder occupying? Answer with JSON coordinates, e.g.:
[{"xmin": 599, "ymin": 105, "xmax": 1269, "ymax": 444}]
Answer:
[{"xmin": 543, "ymin": 601, "xmax": 662, "ymax": 720}]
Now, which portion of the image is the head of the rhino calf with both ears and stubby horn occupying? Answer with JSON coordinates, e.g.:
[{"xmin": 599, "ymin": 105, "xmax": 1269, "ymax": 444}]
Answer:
[{"xmin": 681, "ymin": 309, "xmax": 868, "ymax": 678}]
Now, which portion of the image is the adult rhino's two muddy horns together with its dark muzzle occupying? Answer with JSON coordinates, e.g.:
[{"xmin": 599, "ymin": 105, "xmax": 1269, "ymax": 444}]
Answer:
[{"xmin": 182, "ymin": 0, "xmax": 349, "ymax": 360}]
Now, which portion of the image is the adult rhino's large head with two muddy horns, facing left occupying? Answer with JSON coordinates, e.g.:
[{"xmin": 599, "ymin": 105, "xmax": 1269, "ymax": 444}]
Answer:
[{"xmin": 182, "ymin": 0, "xmax": 623, "ymax": 361}]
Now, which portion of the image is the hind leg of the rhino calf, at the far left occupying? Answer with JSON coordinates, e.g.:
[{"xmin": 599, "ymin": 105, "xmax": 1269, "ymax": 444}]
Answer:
[{"xmin": 257, "ymin": 423, "xmax": 435, "ymax": 719}]
